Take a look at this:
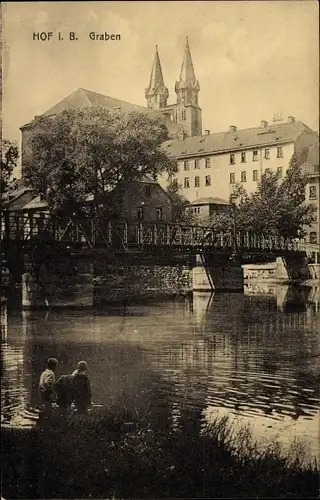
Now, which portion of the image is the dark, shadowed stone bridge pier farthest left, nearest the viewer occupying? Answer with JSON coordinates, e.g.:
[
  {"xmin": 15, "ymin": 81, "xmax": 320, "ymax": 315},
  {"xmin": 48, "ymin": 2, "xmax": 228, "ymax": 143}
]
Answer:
[{"xmin": 22, "ymin": 257, "xmax": 94, "ymax": 309}]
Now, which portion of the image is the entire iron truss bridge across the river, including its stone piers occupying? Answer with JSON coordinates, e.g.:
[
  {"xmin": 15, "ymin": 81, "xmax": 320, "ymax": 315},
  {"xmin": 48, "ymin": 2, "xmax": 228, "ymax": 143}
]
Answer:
[{"xmin": 0, "ymin": 210, "xmax": 319, "ymax": 307}]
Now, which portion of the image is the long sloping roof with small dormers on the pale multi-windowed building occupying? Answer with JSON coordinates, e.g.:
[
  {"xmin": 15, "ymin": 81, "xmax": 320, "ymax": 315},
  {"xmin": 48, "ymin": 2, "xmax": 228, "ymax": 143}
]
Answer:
[{"xmin": 163, "ymin": 121, "xmax": 317, "ymax": 158}]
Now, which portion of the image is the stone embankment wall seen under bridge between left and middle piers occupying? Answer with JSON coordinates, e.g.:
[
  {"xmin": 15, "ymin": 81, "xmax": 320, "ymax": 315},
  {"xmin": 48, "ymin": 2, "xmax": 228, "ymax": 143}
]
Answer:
[{"xmin": 94, "ymin": 264, "xmax": 192, "ymax": 305}]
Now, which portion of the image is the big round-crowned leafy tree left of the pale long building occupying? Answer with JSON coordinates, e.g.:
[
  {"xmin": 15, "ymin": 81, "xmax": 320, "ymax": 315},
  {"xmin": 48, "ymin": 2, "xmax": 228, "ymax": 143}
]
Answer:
[{"xmin": 24, "ymin": 107, "xmax": 177, "ymax": 210}]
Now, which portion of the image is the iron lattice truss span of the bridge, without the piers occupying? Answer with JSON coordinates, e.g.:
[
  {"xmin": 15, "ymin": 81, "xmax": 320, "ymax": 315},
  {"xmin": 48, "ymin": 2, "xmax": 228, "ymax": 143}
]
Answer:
[{"xmin": 0, "ymin": 210, "xmax": 319, "ymax": 258}]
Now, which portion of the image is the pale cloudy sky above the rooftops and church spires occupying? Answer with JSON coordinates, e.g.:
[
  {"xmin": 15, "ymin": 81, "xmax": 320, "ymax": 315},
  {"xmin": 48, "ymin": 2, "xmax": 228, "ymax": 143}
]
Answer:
[{"xmin": 2, "ymin": 0, "xmax": 319, "ymax": 150}]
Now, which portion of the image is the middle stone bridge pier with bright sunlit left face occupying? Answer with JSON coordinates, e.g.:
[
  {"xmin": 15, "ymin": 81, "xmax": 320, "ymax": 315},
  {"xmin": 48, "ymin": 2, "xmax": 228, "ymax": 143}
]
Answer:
[{"xmin": 192, "ymin": 254, "xmax": 243, "ymax": 292}]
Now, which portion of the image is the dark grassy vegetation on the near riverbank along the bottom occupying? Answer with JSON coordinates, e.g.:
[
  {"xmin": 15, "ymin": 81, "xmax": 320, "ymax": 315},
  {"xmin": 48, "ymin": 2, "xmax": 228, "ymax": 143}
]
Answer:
[{"xmin": 1, "ymin": 403, "xmax": 319, "ymax": 499}]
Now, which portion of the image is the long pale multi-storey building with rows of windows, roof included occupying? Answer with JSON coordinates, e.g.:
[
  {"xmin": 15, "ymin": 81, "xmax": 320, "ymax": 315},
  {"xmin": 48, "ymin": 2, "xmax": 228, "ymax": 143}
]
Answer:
[{"xmin": 161, "ymin": 116, "xmax": 319, "ymax": 243}]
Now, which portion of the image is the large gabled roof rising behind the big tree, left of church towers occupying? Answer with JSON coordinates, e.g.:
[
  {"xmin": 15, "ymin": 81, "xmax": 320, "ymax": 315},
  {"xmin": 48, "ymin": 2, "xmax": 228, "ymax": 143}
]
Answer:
[{"xmin": 20, "ymin": 88, "xmax": 181, "ymax": 137}]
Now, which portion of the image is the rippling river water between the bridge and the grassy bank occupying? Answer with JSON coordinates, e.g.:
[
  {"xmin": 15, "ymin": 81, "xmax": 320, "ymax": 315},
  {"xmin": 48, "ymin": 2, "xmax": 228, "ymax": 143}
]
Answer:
[{"xmin": 1, "ymin": 286, "xmax": 320, "ymax": 456}]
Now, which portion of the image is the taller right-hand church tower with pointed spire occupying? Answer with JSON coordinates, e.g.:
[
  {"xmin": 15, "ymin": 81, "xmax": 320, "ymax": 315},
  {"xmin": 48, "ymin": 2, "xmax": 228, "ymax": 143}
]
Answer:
[{"xmin": 175, "ymin": 38, "xmax": 202, "ymax": 137}]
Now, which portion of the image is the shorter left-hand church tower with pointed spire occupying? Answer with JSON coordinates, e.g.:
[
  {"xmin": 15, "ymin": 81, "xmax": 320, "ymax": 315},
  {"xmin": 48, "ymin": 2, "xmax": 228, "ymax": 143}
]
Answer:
[{"xmin": 145, "ymin": 45, "xmax": 169, "ymax": 109}]
